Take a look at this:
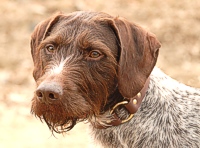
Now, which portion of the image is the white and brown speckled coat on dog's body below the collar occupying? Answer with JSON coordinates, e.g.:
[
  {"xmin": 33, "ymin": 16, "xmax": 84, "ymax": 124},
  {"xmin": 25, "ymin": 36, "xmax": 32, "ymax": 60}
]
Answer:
[{"xmin": 91, "ymin": 68, "xmax": 200, "ymax": 148}]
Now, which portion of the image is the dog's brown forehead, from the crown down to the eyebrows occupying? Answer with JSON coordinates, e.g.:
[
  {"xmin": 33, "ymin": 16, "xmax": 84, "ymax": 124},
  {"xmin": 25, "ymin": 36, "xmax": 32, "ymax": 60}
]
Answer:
[{"xmin": 47, "ymin": 12, "xmax": 116, "ymax": 53}]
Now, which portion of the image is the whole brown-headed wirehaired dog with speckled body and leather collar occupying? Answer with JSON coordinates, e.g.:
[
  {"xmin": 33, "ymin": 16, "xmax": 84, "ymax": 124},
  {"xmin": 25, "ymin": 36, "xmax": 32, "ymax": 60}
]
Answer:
[{"xmin": 31, "ymin": 11, "xmax": 200, "ymax": 148}]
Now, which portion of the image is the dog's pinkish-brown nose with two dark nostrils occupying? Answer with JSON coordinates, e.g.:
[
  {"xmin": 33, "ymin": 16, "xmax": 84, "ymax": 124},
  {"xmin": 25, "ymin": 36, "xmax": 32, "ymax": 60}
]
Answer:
[{"xmin": 36, "ymin": 82, "xmax": 62, "ymax": 103}]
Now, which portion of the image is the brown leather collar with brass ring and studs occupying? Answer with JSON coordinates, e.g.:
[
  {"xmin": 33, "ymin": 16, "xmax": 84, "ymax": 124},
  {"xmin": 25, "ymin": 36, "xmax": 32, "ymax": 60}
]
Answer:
[{"xmin": 94, "ymin": 78, "xmax": 150, "ymax": 129}]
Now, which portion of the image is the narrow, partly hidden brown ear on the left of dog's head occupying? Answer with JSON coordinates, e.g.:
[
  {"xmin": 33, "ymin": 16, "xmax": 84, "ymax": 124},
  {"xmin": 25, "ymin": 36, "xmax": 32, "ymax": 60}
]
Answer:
[{"xmin": 31, "ymin": 13, "xmax": 61, "ymax": 80}]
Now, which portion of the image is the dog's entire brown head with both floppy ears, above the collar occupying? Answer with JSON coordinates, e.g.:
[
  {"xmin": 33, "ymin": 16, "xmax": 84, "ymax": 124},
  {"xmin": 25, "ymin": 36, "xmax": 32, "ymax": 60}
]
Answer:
[{"xmin": 31, "ymin": 12, "xmax": 160, "ymax": 132}]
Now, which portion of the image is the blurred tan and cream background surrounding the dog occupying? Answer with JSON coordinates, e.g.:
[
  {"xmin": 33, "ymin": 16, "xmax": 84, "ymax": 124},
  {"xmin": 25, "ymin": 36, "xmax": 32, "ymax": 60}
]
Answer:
[{"xmin": 0, "ymin": 0, "xmax": 200, "ymax": 148}]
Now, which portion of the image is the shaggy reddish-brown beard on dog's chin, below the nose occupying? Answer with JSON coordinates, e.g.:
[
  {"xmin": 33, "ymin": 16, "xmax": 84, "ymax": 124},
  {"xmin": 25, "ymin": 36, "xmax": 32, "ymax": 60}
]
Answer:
[{"xmin": 31, "ymin": 100, "xmax": 92, "ymax": 133}]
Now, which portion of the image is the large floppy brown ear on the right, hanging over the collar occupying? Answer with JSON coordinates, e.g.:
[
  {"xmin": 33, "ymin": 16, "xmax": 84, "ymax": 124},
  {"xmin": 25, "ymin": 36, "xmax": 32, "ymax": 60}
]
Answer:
[{"xmin": 109, "ymin": 18, "xmax": 161, "ymax": 98}]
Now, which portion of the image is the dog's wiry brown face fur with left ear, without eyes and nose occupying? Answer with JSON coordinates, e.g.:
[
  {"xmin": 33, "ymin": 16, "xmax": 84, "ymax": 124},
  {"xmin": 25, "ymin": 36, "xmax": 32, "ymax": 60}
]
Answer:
[{"xmin": 31, "ymin": 12, "xmax": 118, "ymax": 133}]
